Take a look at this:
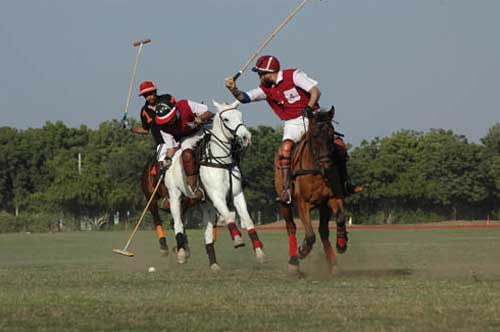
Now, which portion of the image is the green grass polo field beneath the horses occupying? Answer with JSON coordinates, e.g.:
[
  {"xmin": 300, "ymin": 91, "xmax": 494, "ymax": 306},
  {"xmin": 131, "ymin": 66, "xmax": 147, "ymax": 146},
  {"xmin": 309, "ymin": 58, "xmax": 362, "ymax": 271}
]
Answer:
[{"xmin": 0, "ymin": 229, "xmax": 500, "ymax": 332}]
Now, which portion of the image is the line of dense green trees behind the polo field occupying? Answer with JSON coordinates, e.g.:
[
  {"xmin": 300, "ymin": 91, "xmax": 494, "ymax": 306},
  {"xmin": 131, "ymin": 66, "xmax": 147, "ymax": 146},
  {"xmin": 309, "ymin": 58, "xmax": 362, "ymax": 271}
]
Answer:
[{"xmin": 0, "ymin": 121, "xmax": 500, "ymax": 231}]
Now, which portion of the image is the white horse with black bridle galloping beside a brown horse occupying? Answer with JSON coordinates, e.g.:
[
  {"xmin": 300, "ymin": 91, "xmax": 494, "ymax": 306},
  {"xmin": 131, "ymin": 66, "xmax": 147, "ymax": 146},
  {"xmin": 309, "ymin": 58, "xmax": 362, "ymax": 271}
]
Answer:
[{"xmin": 165, "ymin": 101, "xmax": 265, "ymax": 270}]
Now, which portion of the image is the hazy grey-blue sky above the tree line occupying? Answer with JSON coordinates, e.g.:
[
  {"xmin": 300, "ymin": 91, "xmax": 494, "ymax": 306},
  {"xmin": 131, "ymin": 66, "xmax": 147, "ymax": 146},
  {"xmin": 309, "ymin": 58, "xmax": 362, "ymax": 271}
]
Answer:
[{"xmin": 0, "ymin": 0, "xmax": 500, "ymax": 145}]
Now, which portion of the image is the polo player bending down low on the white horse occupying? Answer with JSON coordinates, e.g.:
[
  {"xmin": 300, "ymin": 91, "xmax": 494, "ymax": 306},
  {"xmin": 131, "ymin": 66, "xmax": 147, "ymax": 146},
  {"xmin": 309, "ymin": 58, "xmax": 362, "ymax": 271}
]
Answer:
[{"xmin": 154, "ymin": 97, "xmax": 213, "ymax": 199}]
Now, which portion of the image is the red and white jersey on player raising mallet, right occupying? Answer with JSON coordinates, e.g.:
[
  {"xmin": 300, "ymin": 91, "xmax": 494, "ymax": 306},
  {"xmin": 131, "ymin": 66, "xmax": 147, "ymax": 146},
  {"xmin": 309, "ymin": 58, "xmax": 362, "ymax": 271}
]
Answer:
[{"xmin": 246, "ymin": 69, "xmax": 319, "ymax": 121}]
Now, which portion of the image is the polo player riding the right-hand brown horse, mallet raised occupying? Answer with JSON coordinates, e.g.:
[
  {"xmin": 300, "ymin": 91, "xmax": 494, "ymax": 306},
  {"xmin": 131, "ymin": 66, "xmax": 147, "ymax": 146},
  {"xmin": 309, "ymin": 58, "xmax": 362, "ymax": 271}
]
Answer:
[{"xmin": 226, "ymin": 55, "xmax": 361, "ymax": 204}]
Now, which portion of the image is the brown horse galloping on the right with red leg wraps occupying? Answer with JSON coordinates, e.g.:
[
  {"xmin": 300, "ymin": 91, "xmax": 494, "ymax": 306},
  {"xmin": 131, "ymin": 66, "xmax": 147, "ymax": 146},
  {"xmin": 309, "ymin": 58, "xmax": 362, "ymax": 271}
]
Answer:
[{"xmin": 275, "ymin": 107, "xmax": 347, "ymax": 274}]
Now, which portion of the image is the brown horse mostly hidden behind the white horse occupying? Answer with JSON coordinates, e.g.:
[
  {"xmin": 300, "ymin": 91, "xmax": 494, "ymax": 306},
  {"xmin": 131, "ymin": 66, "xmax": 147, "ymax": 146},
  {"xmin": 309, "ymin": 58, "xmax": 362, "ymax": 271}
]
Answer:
[{"xmin": 141, "ymin": 157, "xmax": 196, "ymax": 255}]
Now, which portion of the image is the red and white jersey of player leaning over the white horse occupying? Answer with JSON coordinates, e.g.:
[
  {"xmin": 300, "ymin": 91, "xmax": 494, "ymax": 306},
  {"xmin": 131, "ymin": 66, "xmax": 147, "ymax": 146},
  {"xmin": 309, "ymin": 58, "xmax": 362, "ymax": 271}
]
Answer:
[{"xmin": 160, "ymin": 99, "xmax": 208, "ymax": 141}]
